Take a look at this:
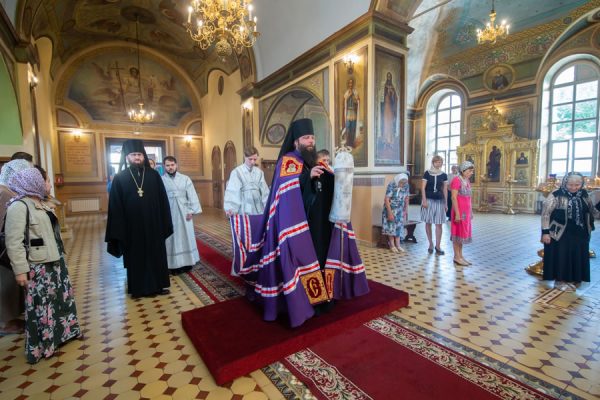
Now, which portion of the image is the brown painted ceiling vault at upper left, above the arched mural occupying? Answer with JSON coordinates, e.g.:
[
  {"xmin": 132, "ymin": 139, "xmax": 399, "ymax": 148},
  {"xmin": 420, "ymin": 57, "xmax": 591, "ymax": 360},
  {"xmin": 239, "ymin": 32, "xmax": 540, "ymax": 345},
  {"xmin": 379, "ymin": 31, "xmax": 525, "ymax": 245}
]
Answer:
[{"xmin": 20, "ymin": 0, "xmax": 248, "ymax": 91}]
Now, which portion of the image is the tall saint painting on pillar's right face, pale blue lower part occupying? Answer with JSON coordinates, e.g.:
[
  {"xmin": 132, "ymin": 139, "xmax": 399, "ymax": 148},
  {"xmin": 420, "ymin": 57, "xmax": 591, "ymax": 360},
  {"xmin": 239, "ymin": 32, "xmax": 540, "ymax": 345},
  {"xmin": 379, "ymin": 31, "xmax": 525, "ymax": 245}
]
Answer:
[{"xmin": 375, "ymin": 48, "xmax": 403, "ymax": 165}]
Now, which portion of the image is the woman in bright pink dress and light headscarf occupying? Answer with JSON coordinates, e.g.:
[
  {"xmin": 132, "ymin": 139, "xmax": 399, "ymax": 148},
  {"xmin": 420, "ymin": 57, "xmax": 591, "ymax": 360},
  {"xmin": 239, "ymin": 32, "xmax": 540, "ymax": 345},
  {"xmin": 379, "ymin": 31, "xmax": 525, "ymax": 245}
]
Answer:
[{"xmin": 450, "ymin": 161, "xmax": 475, "ymax": 265}]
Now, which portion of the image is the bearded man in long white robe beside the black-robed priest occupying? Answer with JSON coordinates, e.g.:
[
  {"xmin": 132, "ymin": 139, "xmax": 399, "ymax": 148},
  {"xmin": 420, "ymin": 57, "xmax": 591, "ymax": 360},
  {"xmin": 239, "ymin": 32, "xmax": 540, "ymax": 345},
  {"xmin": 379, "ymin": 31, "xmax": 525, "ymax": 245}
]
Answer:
[{"xmin": 162, "ymin": 156, "xmax": 202, "ymax": 275}]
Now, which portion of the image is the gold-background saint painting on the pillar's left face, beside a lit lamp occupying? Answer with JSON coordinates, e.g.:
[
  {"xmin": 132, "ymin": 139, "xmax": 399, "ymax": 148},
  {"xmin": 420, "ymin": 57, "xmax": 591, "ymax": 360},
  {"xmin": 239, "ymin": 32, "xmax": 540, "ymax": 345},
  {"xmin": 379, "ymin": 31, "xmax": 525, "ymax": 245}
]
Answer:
[{"xmin": 335, "ymin": 47, "xmax": 368, "ymax": 167}]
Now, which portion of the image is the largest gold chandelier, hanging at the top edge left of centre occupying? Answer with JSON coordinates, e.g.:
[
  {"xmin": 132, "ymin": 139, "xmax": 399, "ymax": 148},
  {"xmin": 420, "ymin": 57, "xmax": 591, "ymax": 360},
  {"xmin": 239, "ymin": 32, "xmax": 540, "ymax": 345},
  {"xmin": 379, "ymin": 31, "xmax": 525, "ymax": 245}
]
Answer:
[{"xmin": 186, "ymin": 0, "xmax": 260, "ymax": 58}]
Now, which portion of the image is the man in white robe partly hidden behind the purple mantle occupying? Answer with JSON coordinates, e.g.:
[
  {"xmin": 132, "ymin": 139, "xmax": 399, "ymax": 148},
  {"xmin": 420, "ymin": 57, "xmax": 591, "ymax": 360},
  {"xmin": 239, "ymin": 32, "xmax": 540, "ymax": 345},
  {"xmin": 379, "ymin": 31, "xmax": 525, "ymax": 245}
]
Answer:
[{"xmin": 223, "ymin": 146, "xmax": 269, "ymax": 216}]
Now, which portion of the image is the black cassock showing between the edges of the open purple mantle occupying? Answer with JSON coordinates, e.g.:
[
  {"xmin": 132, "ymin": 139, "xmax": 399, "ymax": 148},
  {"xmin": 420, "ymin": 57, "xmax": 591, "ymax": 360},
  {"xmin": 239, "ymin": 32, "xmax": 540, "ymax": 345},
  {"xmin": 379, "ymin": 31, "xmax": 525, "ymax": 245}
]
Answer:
[{"xmin": 299, "ymin": 162, "xmax": 334, "ymax": 269}]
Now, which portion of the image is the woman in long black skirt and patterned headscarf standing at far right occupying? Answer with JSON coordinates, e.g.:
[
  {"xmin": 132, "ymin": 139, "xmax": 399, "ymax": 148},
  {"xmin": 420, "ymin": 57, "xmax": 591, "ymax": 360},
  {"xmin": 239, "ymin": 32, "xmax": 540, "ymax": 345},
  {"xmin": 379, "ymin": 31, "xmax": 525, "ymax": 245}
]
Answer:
[{"xmin": 541, "ymin": 172, "xmax": 600, "ymax": 291}]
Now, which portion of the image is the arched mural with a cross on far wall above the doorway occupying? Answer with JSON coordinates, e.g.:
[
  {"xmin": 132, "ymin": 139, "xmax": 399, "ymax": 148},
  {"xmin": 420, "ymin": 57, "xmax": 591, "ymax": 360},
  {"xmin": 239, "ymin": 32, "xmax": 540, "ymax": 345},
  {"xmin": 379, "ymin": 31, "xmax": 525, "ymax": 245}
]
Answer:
[{"xmin": 66, "ymin": 51, "xmax": 193, "ymax": 126}]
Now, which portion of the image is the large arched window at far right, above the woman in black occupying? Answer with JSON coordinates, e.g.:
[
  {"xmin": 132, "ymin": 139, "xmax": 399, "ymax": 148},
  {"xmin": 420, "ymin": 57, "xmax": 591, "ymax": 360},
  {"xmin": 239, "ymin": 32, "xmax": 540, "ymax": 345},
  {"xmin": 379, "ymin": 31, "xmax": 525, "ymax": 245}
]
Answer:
[{"xmin": 546, "ymin": 61, "xmax": 600, "ymax": 177}]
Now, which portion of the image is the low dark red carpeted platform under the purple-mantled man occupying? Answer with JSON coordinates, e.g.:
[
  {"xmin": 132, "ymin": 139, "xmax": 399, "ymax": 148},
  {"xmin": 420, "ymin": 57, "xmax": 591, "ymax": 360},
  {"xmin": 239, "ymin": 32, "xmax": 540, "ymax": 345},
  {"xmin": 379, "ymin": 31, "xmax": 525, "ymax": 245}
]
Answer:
[{"xmin": 181, "ymin": 281, "xmax": 408, "ymax": 385}]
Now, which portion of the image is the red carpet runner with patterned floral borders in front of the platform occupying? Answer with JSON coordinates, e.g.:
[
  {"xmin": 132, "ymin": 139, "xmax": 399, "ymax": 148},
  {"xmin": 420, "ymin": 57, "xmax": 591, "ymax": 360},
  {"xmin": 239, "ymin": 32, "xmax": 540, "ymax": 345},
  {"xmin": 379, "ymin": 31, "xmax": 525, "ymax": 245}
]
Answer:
[{"xmin": 284, "ymin": 318, "xmax": 553, "ymax": 400}]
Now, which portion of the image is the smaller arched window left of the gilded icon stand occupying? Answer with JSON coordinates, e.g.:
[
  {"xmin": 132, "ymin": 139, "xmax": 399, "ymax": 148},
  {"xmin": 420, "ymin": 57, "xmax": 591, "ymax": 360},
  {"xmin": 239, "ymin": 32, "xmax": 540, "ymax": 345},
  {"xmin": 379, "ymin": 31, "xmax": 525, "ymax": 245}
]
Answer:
[{"xmin": 426, "ymin": 89, "xmax": 462, "ymax": 172}]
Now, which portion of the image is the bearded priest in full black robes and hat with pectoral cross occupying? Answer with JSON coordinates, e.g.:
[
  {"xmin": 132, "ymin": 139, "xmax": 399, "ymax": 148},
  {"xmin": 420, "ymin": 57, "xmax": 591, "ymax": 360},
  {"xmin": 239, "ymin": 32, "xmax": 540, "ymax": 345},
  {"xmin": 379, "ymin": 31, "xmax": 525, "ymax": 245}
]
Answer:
[{"xmin": 104, "ymin": 139, "xmax": 173, "ymax": 298}]
